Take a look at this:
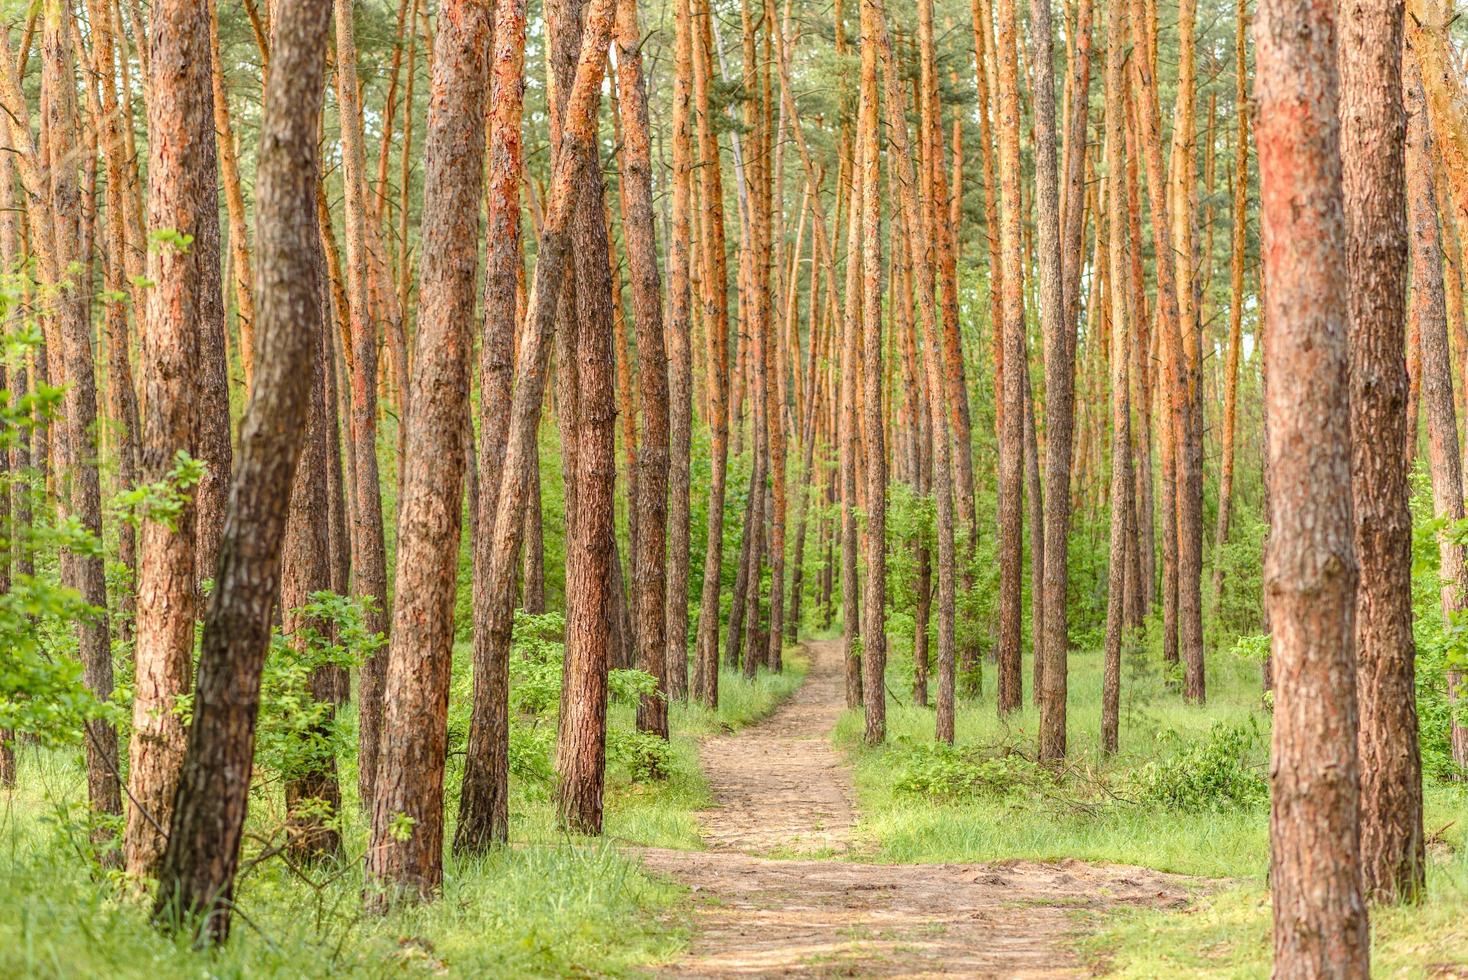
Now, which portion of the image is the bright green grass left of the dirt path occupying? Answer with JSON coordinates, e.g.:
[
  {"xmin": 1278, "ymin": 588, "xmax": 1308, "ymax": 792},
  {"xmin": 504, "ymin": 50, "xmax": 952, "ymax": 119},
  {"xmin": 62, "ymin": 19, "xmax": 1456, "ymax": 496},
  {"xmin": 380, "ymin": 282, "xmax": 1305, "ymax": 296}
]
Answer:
[{"xmin": 0, "ymin": 645, "xmax": 806, "ymax": 980}]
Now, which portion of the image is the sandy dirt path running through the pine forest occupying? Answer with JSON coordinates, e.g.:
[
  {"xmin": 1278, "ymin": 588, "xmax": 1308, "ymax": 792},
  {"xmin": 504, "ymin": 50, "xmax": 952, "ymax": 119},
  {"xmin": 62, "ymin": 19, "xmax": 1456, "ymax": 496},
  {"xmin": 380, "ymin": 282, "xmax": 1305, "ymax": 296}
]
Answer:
[{"xmin": 631, "ymin": 643, "xmax": 1188, "ymax": 977}]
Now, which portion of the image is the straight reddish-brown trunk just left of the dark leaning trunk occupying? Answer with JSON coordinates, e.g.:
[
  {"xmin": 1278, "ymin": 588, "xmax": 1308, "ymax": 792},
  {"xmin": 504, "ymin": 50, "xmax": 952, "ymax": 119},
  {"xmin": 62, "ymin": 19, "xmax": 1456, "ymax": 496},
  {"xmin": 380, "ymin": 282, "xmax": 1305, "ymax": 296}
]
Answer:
[{"xmin": 125, "ymin": 0, "xmax": 216, "ymax": 876}]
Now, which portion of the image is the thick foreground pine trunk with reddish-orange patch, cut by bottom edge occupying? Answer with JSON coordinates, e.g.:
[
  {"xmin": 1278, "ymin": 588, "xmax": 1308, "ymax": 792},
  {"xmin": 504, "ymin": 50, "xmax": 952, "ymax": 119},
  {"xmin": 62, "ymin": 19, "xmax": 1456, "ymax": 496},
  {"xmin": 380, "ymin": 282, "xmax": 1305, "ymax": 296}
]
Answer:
[{"xmin": 1254, "ymin": 0, "xmax": 1370, "ymax": 977}]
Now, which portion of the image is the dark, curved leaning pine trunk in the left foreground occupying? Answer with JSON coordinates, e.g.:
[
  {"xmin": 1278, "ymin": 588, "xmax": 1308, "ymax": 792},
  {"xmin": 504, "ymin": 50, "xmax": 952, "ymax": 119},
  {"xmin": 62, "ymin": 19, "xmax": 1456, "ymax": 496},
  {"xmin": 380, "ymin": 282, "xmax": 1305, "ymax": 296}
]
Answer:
[{"xmin": 156, "ymin": 0, "xmax": 329, "ymax": 942}]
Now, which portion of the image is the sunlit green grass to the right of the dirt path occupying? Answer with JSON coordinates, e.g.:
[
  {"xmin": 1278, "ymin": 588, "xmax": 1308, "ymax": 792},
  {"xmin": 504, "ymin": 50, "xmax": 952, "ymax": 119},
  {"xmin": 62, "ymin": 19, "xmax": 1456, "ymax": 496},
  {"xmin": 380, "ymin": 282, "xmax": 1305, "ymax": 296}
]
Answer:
[{"xmin": 835, "ymin": 630, "xmax": 1468, "ymax": 977}]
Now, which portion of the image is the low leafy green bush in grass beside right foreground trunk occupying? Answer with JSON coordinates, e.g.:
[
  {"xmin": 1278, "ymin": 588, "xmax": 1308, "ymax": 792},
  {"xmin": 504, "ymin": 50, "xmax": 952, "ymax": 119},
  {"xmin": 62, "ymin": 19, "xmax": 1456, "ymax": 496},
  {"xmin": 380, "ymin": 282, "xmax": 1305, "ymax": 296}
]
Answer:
[{"xmin": 1132, "ymin": 719, "xmax": 1270, "ymax": 813}]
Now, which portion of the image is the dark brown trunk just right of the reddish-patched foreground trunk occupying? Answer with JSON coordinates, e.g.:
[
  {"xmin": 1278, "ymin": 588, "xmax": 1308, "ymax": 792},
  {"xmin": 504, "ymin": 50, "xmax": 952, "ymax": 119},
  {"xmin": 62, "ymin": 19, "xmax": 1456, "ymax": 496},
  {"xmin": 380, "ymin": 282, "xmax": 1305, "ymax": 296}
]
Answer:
[{"xmin": 1337, "ymin": 3, "xmax": 1421, "ymax": 899}]
